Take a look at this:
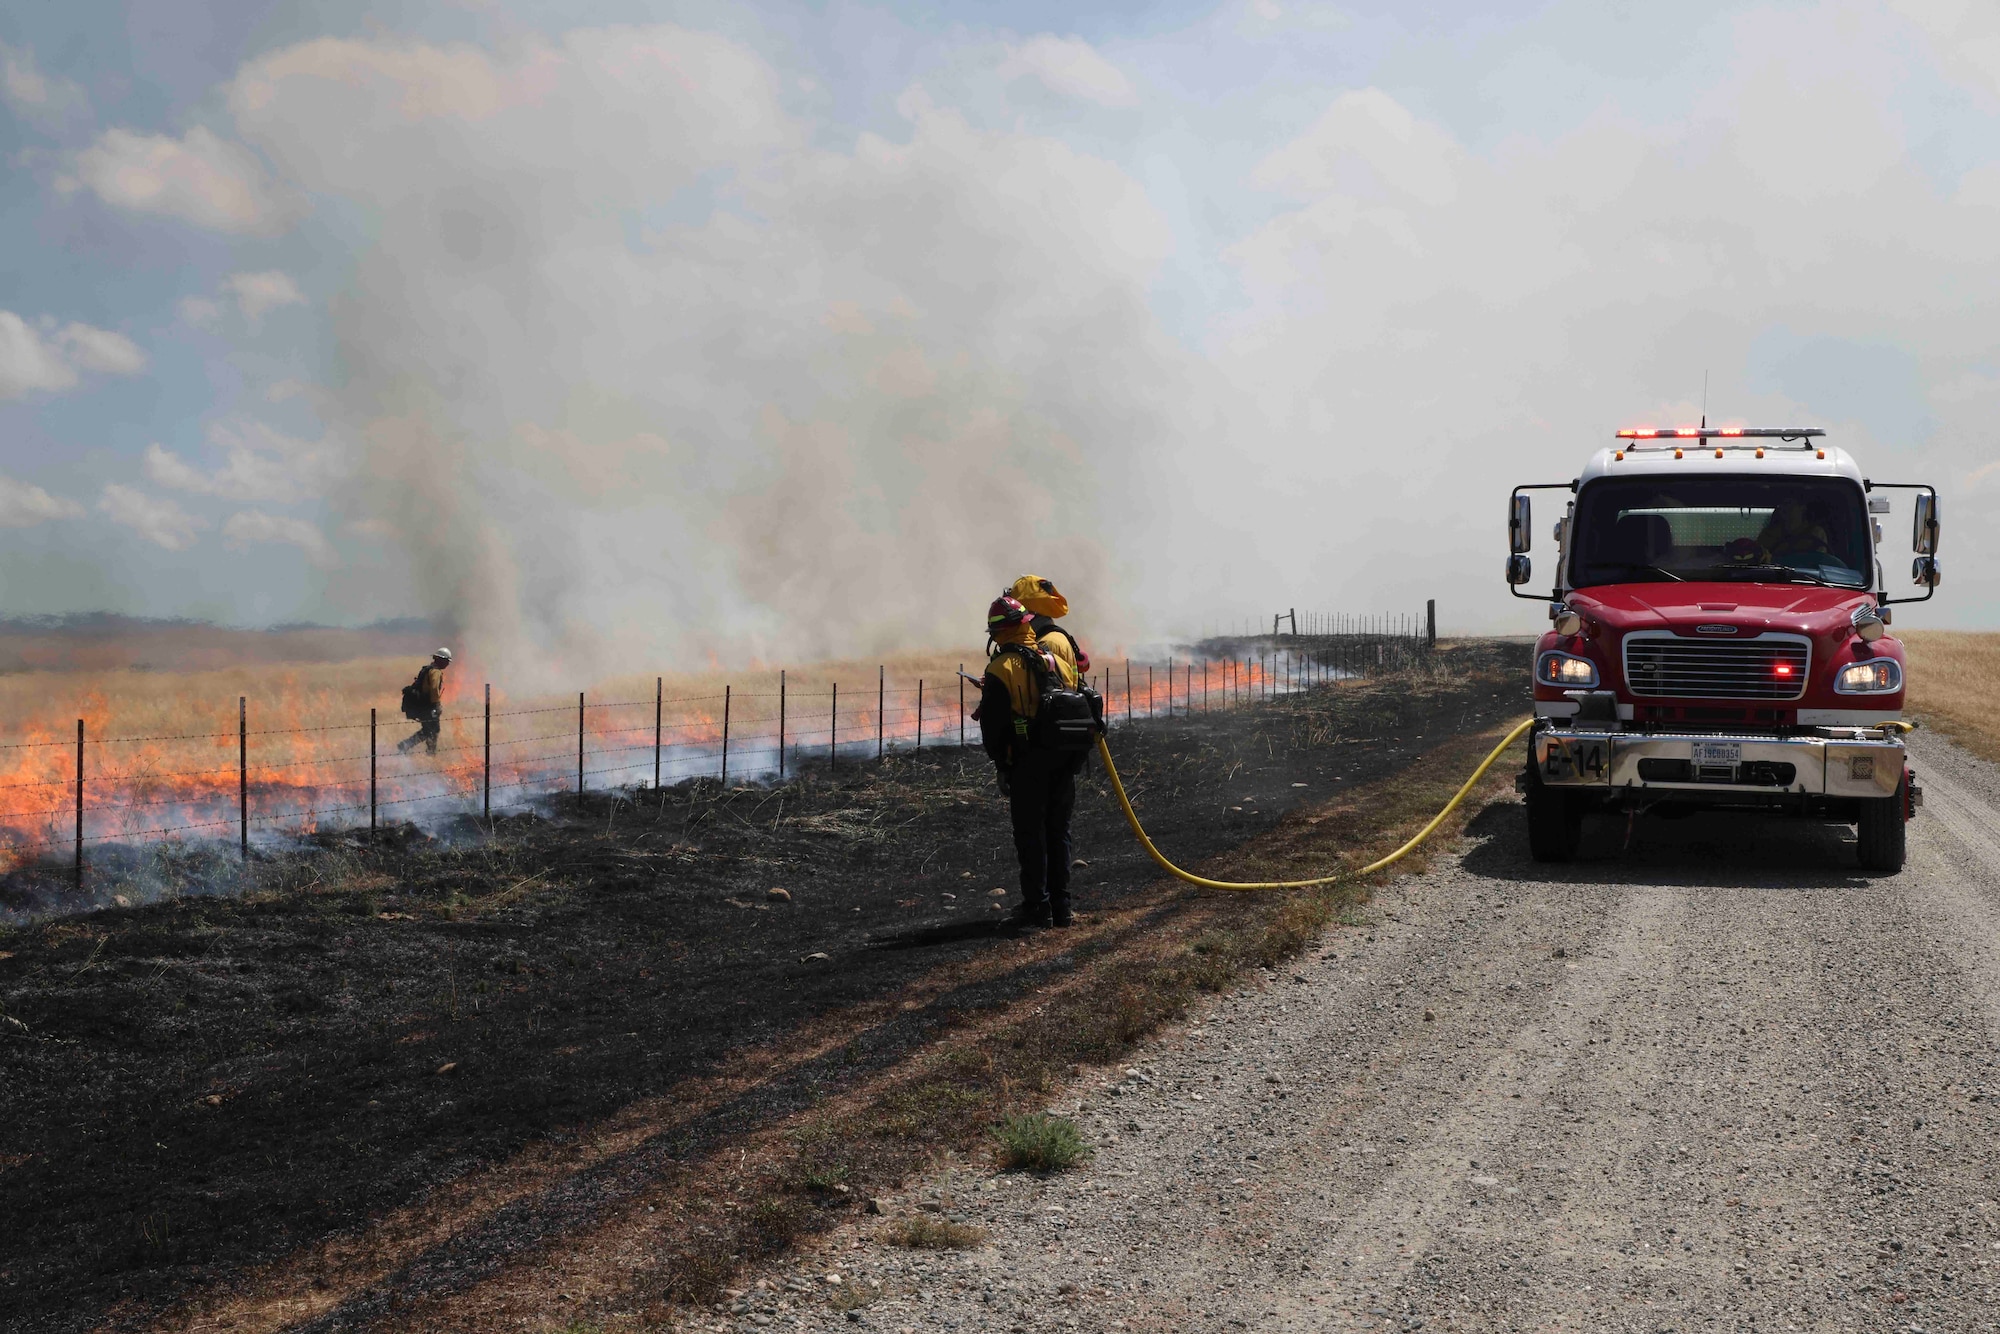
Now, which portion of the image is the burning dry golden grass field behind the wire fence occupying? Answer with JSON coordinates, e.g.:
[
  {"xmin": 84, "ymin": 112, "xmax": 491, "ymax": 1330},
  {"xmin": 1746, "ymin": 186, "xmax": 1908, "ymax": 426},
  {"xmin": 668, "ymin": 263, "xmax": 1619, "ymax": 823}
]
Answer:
[{"xmin": 0, "ymin": 636, "xmax": 1220, "ymax": 850}]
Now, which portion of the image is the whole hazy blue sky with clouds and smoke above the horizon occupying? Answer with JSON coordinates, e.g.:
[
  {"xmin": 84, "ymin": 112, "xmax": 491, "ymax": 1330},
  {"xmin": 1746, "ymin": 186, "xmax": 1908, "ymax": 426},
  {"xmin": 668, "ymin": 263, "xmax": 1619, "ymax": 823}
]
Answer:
[{"xmin": 0, "ymin": 0, "xmax": 2000, "ymax": 676}]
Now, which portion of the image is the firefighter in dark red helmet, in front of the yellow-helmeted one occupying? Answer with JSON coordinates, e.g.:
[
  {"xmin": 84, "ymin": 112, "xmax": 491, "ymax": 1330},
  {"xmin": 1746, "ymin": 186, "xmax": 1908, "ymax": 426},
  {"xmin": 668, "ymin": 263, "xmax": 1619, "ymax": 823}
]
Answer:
[{"xmin": 978, "ymin": 594, "xmax": 1082, "ymax": 930}]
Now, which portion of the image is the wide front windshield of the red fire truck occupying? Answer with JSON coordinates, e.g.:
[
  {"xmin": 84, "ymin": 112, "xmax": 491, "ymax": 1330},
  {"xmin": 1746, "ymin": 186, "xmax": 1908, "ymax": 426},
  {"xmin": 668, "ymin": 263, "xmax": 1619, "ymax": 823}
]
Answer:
[{"xmin": 1570, "ymin": 476, "xmax": 1872, "ymax": 588}]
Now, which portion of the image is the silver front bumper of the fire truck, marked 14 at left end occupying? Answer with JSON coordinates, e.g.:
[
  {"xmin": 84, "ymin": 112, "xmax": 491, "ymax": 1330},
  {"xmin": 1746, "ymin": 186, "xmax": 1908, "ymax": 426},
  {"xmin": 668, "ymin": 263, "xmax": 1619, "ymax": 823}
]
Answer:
[{"xmin": 1530, "ymin": 726, "xmax": 1906, "ymax": 798}]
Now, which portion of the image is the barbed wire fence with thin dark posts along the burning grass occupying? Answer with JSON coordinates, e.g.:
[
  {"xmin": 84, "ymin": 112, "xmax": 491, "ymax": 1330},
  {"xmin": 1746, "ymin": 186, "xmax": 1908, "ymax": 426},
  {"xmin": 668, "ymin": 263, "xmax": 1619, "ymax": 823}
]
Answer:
[{"xmin": 0, "ymin": 610, "xmax": 1436, "ymax": 890}]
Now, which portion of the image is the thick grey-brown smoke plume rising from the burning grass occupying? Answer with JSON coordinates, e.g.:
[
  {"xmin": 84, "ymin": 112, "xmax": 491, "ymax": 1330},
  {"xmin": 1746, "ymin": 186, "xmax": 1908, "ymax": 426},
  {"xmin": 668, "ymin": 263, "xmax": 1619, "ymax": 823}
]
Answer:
[{"xmin": 217, "ymin": 26, "xmax": 1192, "ymax": 672}]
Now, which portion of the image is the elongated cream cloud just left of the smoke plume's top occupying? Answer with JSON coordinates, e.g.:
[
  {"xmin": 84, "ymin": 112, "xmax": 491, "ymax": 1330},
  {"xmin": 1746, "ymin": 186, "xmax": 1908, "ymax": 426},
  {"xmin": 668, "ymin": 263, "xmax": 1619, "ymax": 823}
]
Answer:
[{"xmin": 68, "ymin": 126, "xmax": 298, "ymax": 236}]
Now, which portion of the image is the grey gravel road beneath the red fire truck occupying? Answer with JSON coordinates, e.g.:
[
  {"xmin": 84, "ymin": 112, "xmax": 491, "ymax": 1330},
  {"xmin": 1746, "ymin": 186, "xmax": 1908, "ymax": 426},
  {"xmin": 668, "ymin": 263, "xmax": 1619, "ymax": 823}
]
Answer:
[{"xmin": 716, "ymin": 734, "xmax": 2000, "ymax": 1334}]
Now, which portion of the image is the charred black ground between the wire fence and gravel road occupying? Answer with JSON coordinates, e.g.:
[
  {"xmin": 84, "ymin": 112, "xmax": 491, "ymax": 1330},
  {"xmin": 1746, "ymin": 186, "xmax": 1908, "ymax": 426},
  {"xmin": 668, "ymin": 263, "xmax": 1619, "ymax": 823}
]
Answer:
[{"xmin": 0, "ymin": 644, "xmax": 1520, "ymax": 1330}]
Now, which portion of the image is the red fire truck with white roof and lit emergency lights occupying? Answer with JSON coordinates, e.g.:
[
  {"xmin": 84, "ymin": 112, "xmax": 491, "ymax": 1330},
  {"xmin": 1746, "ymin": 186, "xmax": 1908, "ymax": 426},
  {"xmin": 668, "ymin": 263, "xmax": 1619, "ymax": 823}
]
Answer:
[{"xmin": 1506, "ymin": 424, "xmax": 1938, "ymax": 872}]
